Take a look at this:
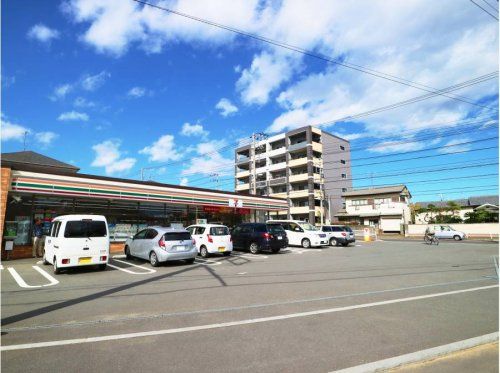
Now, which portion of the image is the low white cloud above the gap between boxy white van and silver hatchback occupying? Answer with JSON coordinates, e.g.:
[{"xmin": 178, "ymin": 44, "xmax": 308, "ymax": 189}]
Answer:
[{"xmin": 91, "ymin": 140, "xmax": 136, "ymax": 175}]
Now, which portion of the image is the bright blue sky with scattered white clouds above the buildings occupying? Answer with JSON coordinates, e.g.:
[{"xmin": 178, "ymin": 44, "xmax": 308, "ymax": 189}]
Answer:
[{"xmin": 2, "ymin": 0, "xmax": 498, "ymax": 201}]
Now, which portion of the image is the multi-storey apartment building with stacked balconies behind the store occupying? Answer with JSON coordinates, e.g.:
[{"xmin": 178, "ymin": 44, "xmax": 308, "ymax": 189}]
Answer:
[{"xmin": 235, "ymin": 126, "xmax": 352, "ymax": 223}]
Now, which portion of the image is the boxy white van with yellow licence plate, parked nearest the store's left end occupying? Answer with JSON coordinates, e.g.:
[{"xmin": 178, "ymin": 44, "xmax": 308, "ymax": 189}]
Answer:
[{"xmin": 43, "ymin": 215, "xmax": 109, "ymax": 274}]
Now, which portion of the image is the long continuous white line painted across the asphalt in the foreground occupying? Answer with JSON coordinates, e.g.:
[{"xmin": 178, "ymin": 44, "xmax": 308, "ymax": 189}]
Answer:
[{"xmin": 0, "ymin": 285, "xmax": 498, "ymax": 351}]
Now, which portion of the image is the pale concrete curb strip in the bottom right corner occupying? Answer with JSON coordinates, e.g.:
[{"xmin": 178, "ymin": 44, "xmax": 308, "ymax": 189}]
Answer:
[{"xmin": 332, "ymin": 332, "xmax": 498, "ymax": 373}]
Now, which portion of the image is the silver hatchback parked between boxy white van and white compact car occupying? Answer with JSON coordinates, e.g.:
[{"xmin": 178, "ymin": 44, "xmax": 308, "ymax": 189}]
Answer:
[{"xmin": 125, "ymin": 227, "xmax": 198, "ymax": 267}]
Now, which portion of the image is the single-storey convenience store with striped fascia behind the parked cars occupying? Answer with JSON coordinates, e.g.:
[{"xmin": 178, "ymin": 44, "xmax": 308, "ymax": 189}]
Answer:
[{"xmin": 0, "ymin": 151, "xmax": 288, "ymax": 259}]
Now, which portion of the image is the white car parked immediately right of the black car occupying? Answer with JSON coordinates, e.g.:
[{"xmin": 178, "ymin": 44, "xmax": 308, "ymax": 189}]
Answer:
[{"xmin": 267, "ymin": 220, "xmax": 328, "ymax": 248}]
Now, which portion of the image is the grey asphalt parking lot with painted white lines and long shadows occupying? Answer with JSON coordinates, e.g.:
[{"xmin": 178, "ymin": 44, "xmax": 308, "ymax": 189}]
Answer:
[{"xmin": 1, "ymin": 241, "xmax": 498, "ymax": 372}]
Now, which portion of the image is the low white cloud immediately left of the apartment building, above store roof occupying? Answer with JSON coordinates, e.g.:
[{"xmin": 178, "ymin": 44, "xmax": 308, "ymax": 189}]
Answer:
[{"xmin": 181, "ymin": 140, "xmax": 234, "ymax": 176}]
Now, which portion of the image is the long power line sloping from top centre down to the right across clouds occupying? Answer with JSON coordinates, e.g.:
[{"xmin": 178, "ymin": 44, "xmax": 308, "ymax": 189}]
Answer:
[{"xmin": 133, "ymin": 0, "xmax": 494, "ymax": 105}]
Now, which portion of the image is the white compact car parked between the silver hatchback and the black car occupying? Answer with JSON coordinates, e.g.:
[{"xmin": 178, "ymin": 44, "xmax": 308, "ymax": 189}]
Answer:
[{"xmin": 186, "ymin": 224, "xmax": 233, "ymax": 258}]
